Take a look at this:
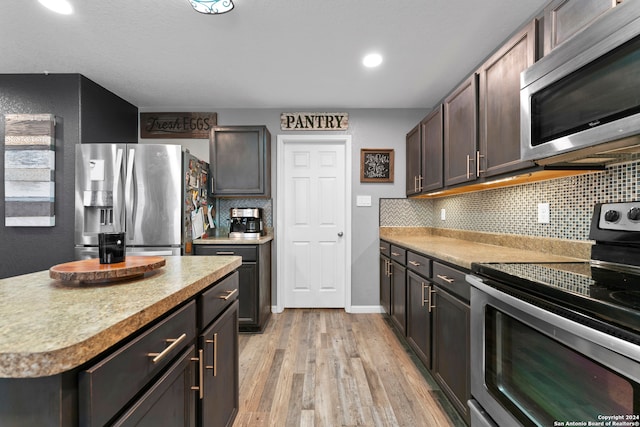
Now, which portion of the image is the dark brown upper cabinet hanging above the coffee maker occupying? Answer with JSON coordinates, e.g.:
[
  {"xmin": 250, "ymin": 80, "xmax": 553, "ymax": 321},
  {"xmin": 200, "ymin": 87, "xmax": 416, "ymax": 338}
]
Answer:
[{"xmin": 209, "ymin": 126, "xmax": 271, "ymax": 197}]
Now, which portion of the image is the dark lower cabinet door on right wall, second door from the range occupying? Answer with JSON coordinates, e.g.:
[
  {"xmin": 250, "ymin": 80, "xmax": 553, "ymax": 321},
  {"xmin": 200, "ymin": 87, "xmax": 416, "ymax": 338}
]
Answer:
[{"xmin": 407, "ymin": 271, "xmax": 433, "ymax": 369}]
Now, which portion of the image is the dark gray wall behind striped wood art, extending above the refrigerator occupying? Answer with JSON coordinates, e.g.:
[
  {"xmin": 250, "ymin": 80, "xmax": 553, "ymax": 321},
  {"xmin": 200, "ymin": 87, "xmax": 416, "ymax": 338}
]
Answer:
[{"xmin": 0, "ymin": 74, "xmax": 138, "ymax": 278}]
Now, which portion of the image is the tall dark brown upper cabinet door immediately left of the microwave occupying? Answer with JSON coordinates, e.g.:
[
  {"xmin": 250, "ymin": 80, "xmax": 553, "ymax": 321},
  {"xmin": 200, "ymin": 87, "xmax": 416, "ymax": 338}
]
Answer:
[{"xmin": 477, "ymin": 21, "xmax": 537, "ymax": 177}]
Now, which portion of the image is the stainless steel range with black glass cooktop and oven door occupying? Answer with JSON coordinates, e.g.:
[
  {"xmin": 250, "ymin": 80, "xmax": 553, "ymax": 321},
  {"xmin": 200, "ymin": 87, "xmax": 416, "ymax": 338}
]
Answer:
[{"xmin": 467, "ymin": 202, "xmax": 640, "ymax": 426}]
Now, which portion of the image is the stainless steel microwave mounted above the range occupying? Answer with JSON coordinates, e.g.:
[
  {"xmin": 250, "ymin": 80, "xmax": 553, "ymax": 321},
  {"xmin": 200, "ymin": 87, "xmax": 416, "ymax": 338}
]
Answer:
[{"xmin": 520, "ymin": 1, "xmax": 640, "ymax": 165}]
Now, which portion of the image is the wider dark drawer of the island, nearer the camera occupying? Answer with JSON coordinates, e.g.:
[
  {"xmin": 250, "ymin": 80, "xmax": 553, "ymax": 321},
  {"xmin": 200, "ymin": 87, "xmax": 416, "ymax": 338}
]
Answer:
[{"xmin": 78, "ymin": 301, "xmax": 196, "ymax": 426}]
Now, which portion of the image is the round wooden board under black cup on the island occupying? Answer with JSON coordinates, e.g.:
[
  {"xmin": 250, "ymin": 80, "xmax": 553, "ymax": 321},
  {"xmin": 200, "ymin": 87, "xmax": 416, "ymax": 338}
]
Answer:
[{"xmin": 49, "ymin": 256, "xmax": 167, "ymax": 282}]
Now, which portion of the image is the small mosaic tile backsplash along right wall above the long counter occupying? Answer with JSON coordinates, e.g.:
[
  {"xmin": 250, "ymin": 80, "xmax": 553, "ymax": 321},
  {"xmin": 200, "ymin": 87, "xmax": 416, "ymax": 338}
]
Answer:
[{"xmin": 380, "ymin": 162, "xmax": 640, "ymax": 240}]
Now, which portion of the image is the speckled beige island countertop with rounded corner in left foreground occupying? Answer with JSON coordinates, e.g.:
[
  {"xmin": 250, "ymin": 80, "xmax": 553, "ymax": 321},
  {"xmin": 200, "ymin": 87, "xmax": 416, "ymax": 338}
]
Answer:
[{"xmin": 0, "ymin": 256, "xmax": 242, "ymax": 378}]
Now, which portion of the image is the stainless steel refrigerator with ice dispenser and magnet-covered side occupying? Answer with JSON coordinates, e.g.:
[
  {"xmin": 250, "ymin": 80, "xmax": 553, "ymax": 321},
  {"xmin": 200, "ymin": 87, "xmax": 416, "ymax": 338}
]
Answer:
[{"xmin": 75, "ymin": 144, "xmax": 208, "ymax": 259}]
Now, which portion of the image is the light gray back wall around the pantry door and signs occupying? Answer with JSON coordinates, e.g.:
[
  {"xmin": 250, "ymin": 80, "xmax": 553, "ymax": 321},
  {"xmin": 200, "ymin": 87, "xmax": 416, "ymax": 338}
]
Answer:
[{"xmin": 140, "ymin": 108, "xmax": 428, "ymax": 307}]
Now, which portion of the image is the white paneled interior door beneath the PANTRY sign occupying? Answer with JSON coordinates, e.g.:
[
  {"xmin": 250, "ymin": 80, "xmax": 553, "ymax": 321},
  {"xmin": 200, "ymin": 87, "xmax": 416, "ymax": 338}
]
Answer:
[{"xmin": 277, "ymin": 136, "xmax": 351, "ymax": 308}]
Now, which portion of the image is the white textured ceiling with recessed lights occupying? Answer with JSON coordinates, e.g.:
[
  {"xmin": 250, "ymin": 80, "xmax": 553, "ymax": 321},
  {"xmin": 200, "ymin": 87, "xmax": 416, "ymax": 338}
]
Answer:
[{"xmin": 0, "ymin": 0, "xmax": 546, "ymax": 111}]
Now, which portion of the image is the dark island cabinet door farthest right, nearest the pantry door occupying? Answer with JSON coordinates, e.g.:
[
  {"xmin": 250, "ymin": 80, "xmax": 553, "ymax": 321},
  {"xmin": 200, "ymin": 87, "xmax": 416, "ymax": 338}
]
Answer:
[{"xmin": 199, "ymin": 300, "xmax": 239, "ymax": 427}]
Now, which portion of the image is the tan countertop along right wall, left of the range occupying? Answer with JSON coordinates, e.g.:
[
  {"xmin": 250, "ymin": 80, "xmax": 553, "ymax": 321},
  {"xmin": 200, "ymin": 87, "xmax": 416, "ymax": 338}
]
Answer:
[{"xmin": 380, "ymin": 227, "xmax": 592, "ymax": 270}]
